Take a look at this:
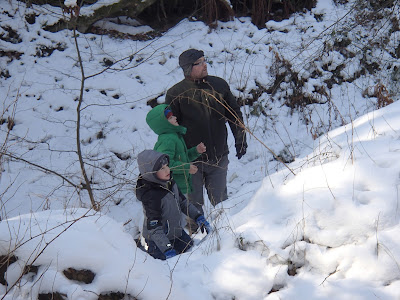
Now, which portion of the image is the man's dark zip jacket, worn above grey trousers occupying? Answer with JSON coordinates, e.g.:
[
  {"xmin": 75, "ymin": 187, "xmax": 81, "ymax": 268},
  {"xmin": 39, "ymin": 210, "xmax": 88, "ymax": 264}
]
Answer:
[{"xmin": 165, "ymin": 76, "xmax": 247, "ymax": 161}]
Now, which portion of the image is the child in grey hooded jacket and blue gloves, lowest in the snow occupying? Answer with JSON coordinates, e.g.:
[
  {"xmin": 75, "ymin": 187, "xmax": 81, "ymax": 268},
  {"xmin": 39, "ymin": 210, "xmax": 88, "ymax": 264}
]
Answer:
[{"xmin": 135, "ymin": 150, "xmax": 212, "ymax": 260}]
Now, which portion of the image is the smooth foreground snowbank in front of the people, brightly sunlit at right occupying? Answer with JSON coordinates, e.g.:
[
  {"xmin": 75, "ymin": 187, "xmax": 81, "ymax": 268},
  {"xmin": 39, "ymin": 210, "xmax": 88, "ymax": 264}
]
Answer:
[{"xmin": 0, "ymin": 102, "xmax": 400, "ymax": 300}]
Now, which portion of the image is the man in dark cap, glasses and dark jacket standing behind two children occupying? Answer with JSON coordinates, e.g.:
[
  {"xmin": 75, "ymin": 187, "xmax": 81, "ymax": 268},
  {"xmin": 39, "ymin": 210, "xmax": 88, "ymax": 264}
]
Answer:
[{"xmin": 165, "ymin": 49, "xmax": 247, "ymax": 229}]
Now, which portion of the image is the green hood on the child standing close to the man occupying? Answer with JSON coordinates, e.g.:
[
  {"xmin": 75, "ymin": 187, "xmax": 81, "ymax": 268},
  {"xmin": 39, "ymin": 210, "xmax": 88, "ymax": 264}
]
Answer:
[{"xmin": 146, "ymin": 104, "xmax": 186, "ymax": 135}]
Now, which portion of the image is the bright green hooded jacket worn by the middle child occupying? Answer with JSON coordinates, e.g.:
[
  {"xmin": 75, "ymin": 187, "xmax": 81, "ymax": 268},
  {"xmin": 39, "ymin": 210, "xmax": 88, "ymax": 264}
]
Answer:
[{"xmin": 146, "ymin": 104, "xmax": 200, "ymax": 194}]
